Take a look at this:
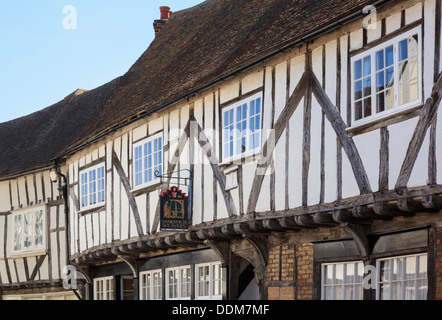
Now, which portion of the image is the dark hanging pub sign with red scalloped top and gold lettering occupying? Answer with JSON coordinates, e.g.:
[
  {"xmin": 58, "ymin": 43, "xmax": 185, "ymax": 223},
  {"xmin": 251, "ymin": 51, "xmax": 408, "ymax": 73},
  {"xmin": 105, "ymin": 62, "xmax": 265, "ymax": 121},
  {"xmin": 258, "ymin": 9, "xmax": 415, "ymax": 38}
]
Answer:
[{"xmin": 160, "ymin": 187, "xmax": 189, "ymax": 231}]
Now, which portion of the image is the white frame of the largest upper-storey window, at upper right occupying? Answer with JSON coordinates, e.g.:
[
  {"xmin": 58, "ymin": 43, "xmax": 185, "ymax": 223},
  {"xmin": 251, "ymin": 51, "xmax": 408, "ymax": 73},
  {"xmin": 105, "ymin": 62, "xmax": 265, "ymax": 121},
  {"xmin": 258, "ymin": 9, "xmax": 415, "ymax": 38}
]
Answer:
[{"xmin": 349, "ymin": 26, "xmax": 423, "ymax": 128}]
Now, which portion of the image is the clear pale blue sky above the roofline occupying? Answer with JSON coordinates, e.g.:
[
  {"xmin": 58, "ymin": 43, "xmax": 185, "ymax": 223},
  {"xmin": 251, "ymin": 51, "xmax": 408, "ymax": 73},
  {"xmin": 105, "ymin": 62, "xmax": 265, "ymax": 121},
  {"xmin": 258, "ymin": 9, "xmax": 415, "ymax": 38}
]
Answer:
[{"xmin": 0, "ymin": 0, "xmax": 203, "ymax": 123}]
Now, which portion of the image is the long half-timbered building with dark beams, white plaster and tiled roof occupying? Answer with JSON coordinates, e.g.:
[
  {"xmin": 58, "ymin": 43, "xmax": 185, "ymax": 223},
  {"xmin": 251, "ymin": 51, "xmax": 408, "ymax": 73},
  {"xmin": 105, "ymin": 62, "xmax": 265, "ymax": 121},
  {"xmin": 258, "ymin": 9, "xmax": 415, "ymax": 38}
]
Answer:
[{"xmin": 0, "ymin": 0, "xmax": 442, "ymax": 300}]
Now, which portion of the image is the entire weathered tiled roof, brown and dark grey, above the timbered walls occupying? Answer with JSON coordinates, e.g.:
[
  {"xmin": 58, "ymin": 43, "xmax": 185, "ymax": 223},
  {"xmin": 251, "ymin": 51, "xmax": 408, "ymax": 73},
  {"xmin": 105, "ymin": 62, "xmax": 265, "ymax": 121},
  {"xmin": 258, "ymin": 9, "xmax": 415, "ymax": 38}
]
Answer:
[{"xmin": 0, "ymin": 0, "xmax": 375, "ymax": 176}]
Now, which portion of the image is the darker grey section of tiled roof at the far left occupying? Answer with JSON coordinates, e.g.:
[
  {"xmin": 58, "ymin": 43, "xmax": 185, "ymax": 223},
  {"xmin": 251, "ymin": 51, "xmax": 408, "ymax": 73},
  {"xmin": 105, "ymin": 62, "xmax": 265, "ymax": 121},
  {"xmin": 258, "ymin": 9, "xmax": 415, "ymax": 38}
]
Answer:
[{"xmin": 0, "ymin": 78, "xmax": 119, "ymax": 177}]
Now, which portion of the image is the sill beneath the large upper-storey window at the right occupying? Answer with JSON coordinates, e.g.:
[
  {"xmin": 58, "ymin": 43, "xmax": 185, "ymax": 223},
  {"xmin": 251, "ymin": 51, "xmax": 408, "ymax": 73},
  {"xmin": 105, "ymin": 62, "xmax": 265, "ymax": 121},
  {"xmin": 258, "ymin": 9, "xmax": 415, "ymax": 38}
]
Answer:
[{"xmin": 346, "ymin": 104, "xmax": 423, "ymax": 137}]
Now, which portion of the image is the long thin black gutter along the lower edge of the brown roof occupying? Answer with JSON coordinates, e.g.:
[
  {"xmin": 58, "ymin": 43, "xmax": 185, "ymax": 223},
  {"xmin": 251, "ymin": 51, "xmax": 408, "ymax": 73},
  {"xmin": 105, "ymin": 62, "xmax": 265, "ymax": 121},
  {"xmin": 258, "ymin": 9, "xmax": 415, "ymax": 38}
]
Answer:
[{"xmin": 51, "ymin": 0, "xmax": 394, "ymax": 161}]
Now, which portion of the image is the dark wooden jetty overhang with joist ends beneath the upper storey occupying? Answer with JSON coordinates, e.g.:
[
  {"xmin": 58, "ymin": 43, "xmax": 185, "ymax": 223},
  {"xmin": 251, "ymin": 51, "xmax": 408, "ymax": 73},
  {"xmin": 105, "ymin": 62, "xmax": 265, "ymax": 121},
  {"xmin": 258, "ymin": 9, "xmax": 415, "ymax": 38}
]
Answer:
[{"xmin": 71, "ymin": 185, "xmax": 442, "ymax": 265}]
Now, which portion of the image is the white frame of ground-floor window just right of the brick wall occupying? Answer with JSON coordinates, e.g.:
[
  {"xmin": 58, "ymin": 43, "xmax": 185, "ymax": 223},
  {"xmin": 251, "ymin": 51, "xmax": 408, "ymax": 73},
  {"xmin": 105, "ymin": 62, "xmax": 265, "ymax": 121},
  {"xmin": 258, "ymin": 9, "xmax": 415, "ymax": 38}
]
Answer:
[{"xmin": 321, "ymin": 261, "xmax": 364, "ymax": 300}]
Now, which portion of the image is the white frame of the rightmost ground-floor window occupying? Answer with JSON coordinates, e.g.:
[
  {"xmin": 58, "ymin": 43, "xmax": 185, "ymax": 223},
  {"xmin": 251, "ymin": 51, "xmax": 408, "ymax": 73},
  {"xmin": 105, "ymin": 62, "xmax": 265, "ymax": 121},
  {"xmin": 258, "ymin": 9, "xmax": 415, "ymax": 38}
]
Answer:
[{"xmin": 376, "ymin": 253, "xmax": 429, "ymax": 300}]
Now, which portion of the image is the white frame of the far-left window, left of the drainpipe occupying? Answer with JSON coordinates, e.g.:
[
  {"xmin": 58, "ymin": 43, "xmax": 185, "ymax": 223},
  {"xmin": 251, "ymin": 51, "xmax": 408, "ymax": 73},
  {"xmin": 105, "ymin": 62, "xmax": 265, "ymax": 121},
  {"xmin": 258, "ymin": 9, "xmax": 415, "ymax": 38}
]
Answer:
[{"xmin": 10, "ymin": 206, "xmax": 47, "ymax": 256}]
